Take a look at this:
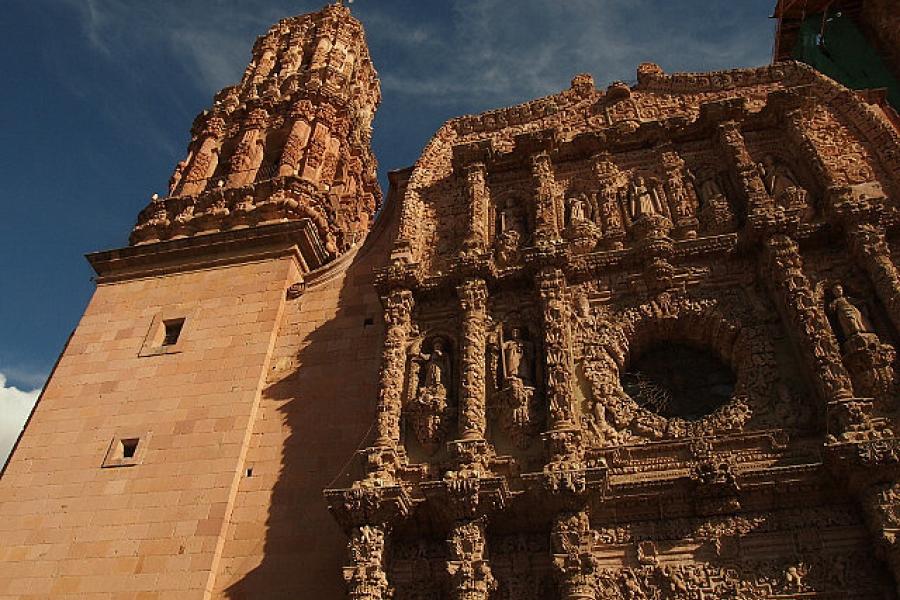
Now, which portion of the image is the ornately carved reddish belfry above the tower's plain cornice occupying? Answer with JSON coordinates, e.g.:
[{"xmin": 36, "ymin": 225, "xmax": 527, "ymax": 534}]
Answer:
[{"xmin": 131, "ymin": 4, "xmax": 381, "ymax": 258}]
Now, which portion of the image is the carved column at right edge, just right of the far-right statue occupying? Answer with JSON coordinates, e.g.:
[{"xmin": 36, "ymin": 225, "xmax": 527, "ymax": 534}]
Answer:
[{"xmin": 847, "ymin": 223, "xmax": 900, "ymax": 331}]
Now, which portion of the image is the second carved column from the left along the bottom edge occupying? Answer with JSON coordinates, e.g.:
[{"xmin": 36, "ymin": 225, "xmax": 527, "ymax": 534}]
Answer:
[{"xmin": 447, "ymin": 519, "xmax": 497, "ymax": 600}]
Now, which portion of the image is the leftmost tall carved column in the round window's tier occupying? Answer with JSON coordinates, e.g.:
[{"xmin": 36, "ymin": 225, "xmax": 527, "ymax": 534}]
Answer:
[{"xmin": 375, "ymin": 289, "xmax": 413, "ymax": 446}]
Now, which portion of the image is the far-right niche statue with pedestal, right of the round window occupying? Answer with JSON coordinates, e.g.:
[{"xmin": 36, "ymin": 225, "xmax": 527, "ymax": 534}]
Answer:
[{"xmin": 827, "ymin": 283, "xmax": 896, "ymax": 398}]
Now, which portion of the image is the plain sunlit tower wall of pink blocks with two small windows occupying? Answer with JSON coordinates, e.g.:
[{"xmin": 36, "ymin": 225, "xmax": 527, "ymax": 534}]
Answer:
[{"xmin": 0, "ymin": 258, "xmax": 297, "ymax": 600}]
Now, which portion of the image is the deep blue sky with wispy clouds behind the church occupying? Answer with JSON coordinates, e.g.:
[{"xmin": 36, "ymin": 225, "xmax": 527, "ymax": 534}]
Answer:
[{"xmin": 0, "ymin": 0, "xmax": 774, "ymax": 464}]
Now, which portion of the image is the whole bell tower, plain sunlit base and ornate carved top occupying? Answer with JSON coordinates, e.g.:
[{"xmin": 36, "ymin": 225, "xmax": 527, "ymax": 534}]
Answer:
[{"xmin": 0, "ymin": 4, "xmax": 381, "ymax": 600}]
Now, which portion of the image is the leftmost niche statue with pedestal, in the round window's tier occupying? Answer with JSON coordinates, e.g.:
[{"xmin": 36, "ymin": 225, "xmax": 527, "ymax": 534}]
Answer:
[{"xmin": 407, "ymin": 336, "xmax": 452, "ymax": 452}]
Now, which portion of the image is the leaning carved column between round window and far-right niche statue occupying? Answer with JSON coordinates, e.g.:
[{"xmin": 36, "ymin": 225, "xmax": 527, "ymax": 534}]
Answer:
[{"xmin": 764, "ymin": 234, "xmax": 853, "ymax": 403}]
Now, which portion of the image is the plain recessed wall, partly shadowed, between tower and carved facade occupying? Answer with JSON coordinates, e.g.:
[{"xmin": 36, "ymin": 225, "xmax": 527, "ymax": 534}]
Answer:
[{"xmin": 214, "ymin": 177, "xmax": 399, "ymax": 600}]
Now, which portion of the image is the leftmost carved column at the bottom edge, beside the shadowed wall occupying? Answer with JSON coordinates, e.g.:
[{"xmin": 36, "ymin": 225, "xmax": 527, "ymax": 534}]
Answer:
[{"xmin": 344, "ymin": 525, "xmax": 391, "ymax": 600}]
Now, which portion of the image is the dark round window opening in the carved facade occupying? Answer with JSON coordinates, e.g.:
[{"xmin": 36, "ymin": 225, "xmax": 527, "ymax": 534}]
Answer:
[{"xmin": 621, "ymin": 342, "xmax": 735, "ymax": 421}]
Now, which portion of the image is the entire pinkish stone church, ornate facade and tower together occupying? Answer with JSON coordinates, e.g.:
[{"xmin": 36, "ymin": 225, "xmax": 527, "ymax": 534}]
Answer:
[{"xmin": 0, "ymin": 4, "xmax": 900, "ymax": 600}]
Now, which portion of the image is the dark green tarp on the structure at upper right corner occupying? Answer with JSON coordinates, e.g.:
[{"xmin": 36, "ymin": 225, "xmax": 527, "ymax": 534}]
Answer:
[{"xmin": 793, "ymin": 13, "xmax": 900, "ymax": 111}]
